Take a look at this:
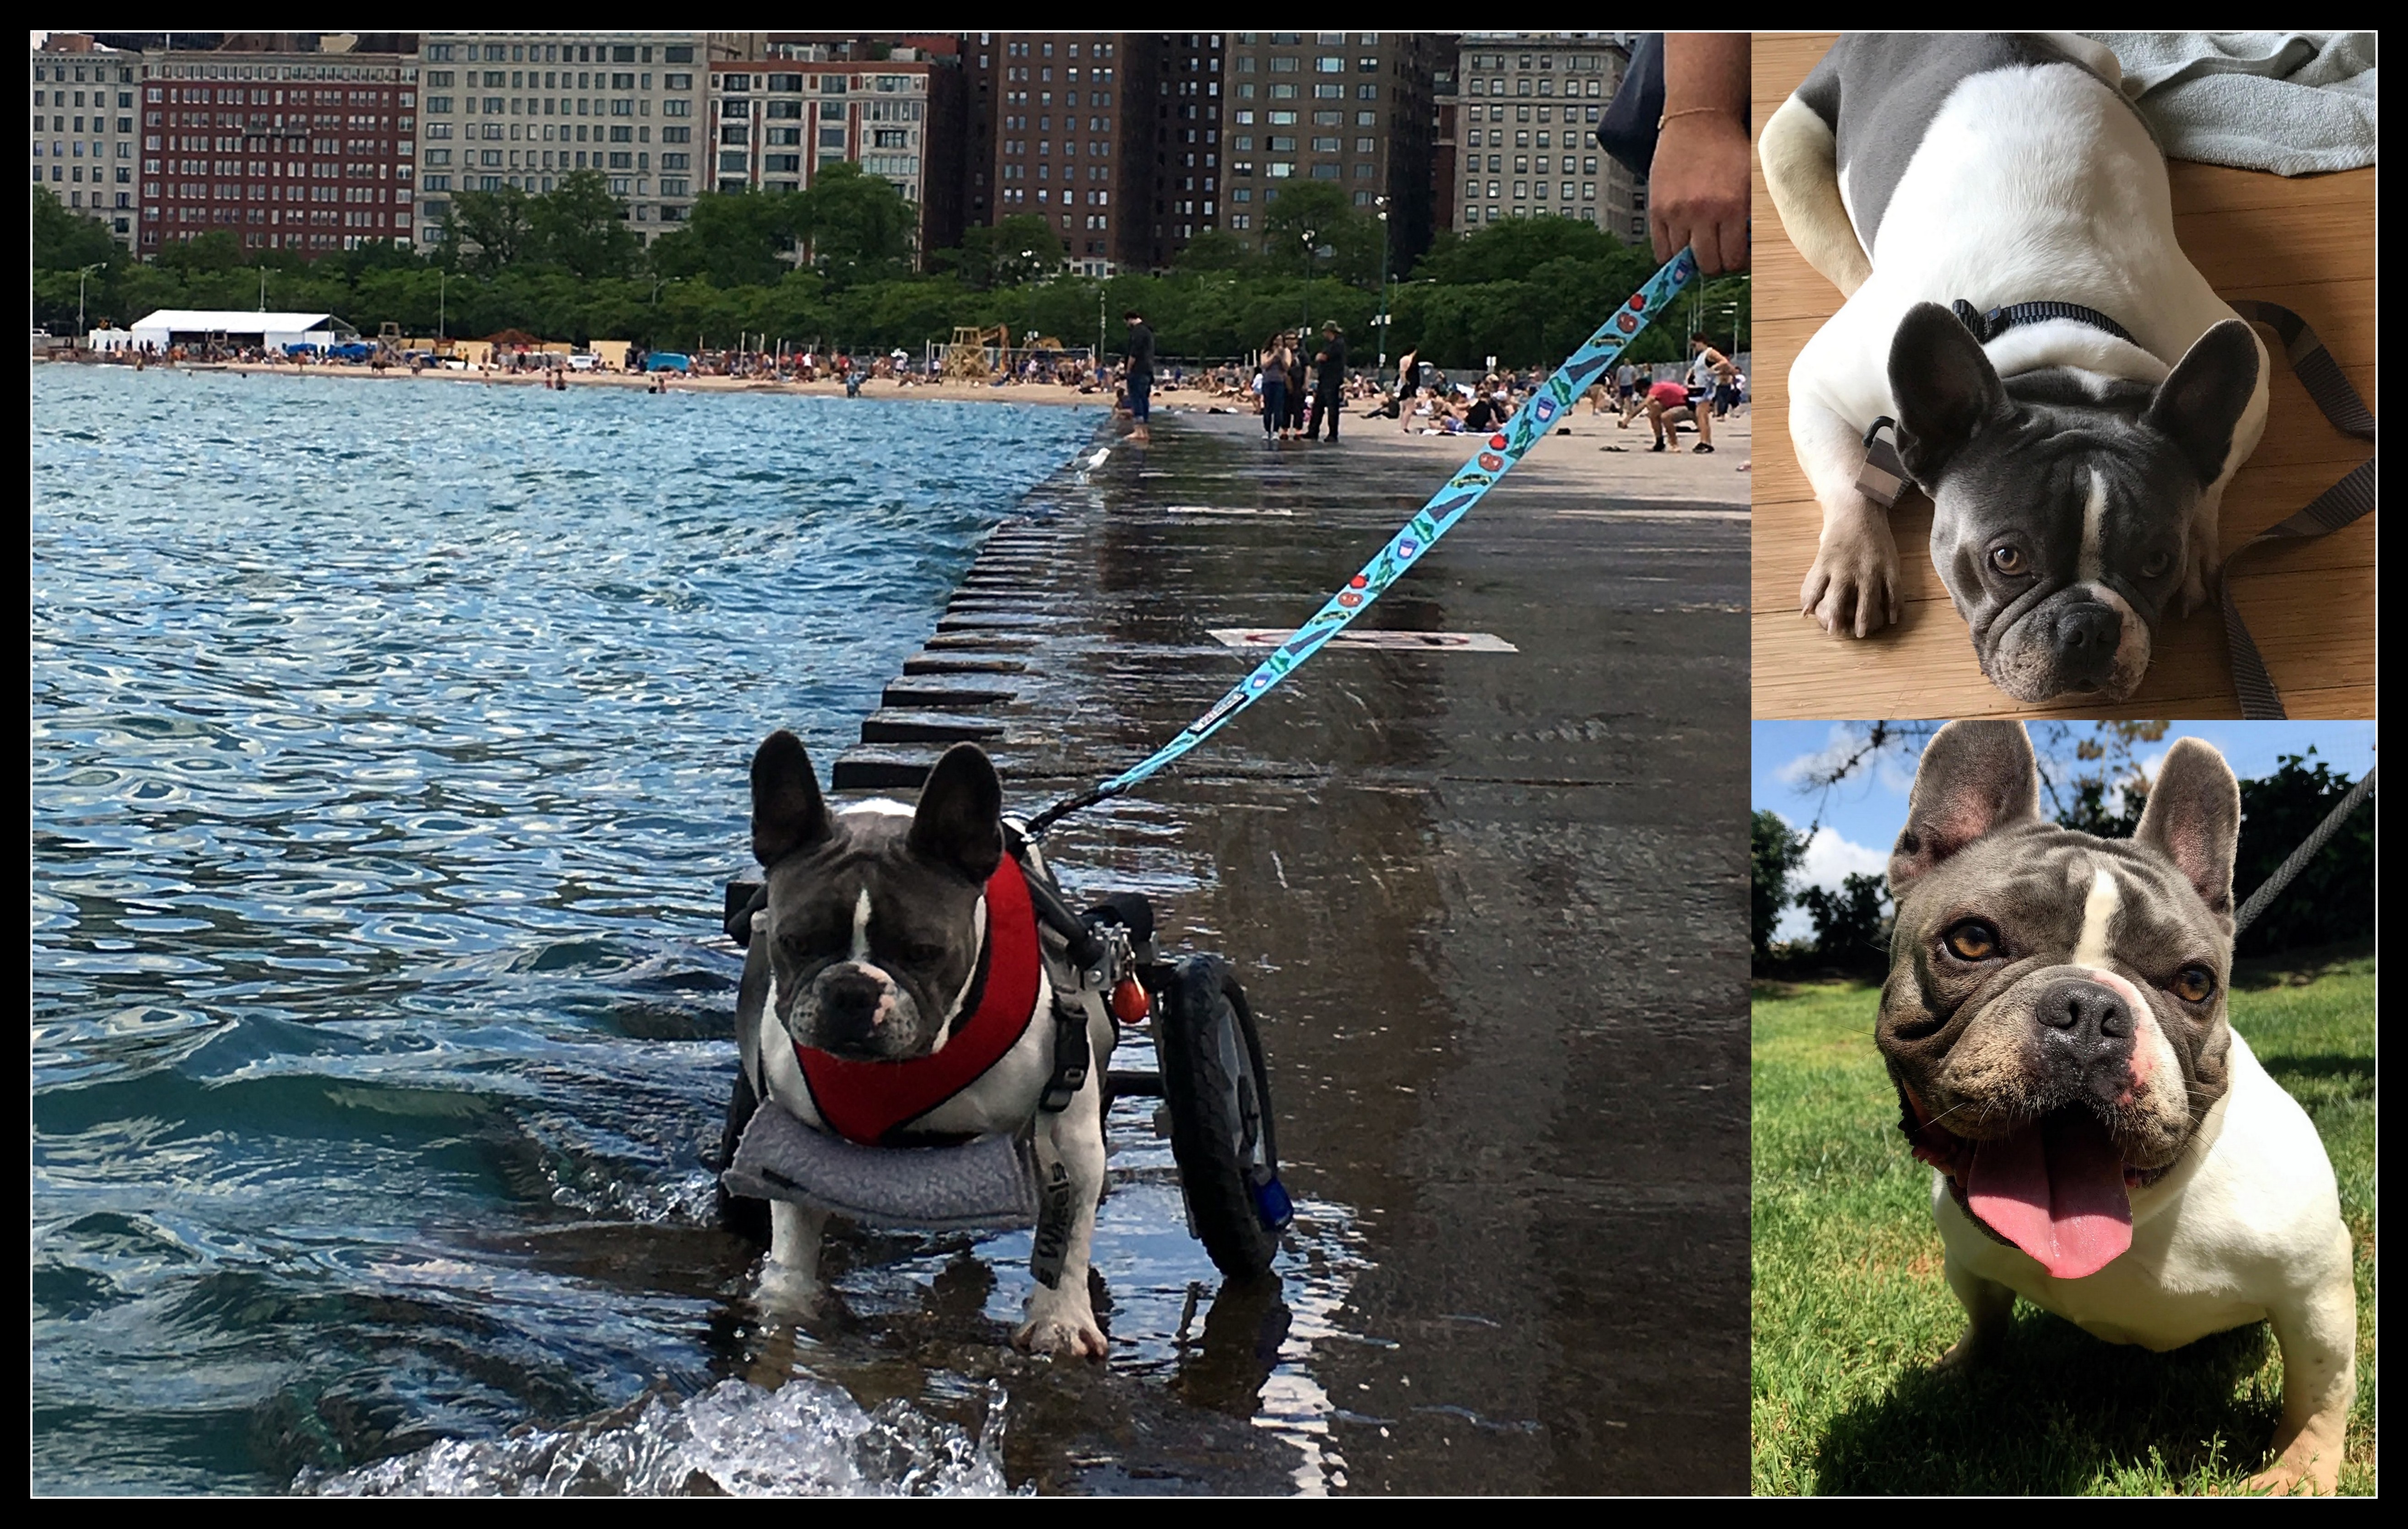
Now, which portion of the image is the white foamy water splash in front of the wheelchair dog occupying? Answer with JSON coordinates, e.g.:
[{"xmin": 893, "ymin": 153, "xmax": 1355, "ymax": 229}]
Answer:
[{"xmin": 294, "ymin": 1380, "xmax": 1011, "ymax": 1498}]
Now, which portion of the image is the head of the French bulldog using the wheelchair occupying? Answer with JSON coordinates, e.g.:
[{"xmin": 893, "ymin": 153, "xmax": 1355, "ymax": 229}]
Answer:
[{"xmin": 751, "ymin": 732, "xmax": 1004, "ymax": 1062}]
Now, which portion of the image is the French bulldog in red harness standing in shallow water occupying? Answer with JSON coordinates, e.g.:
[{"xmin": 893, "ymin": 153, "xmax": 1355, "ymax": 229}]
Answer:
[{"xmin": 729, "ymin": 732, "xmax": 1115, "ymax": 1358}]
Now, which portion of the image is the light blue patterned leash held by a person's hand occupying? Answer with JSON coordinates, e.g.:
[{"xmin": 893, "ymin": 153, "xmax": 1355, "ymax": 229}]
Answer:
[{"xmin": 1026, "ymin": 250, "xmax": 1698, "ymax": 838}]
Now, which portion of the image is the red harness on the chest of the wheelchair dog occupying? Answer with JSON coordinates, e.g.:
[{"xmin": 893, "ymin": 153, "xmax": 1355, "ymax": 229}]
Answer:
[{"xmin": 794, "ymin": 855, "xmax": 1045, "ymax": 1146}]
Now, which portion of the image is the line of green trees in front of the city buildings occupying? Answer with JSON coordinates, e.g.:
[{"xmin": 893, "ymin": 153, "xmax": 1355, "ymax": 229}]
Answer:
[{"xmin": 34, "ymin": 164, "xmax": 1748, "ymax": 371}]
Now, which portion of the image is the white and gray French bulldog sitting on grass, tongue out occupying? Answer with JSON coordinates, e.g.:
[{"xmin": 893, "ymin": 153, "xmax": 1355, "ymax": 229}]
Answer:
[{"xmin": 1876, "ymin": 722, "xmax": 2357, "ymax": 1493}]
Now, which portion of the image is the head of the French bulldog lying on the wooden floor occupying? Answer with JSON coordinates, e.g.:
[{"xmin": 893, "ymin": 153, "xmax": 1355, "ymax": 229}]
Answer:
[{"xmin": 1890, "ymin": 303, "xmax": 2256, "ymax": 701}]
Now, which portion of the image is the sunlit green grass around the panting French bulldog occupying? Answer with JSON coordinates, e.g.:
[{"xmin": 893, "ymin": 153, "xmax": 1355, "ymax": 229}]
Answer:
[{"xmin": 1750, "ymin": 951, "xmax": 2374, "ymax": 1495}]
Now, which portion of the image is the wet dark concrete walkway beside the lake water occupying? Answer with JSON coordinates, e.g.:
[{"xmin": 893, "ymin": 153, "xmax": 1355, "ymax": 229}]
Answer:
[{"xmin": 836, "ymin": 414, "xmax": 1748, "ymax": 1493}]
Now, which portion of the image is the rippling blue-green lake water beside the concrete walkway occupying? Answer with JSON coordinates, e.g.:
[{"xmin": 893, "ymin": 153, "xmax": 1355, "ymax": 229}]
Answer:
[{"xmin": 31, "ymin": 366, "xmax": 1122, "ymax": 1493}]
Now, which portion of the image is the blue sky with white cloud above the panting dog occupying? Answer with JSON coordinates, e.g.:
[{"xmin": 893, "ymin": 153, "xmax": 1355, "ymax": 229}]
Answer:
[{"xmin": 1748, "ymin": 722, "xmax": 2374, "ymax": 939}]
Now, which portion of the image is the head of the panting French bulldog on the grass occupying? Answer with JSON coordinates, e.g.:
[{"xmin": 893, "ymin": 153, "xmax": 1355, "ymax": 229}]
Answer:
[{"xmin": 1876, "ymin": 722, "xmax": 2240, "ymax": 1279}]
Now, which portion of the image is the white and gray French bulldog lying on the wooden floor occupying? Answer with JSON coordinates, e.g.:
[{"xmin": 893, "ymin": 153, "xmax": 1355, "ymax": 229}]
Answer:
[{"xmin": 1760, "ymin": 34, "xmax": 2266, "ymax": 703}]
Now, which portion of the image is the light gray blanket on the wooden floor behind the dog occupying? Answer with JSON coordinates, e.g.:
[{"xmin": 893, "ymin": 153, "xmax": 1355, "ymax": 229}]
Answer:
[{"xmin": 2083, "ymin": 31, "xmax": 2374, "ymax": 176}]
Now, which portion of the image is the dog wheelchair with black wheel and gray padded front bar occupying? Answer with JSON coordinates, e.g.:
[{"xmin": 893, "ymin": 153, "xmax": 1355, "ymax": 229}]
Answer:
[{"xmin": 715, "ymin": 833, "xmax": 1293, "ymax": 1279}]
